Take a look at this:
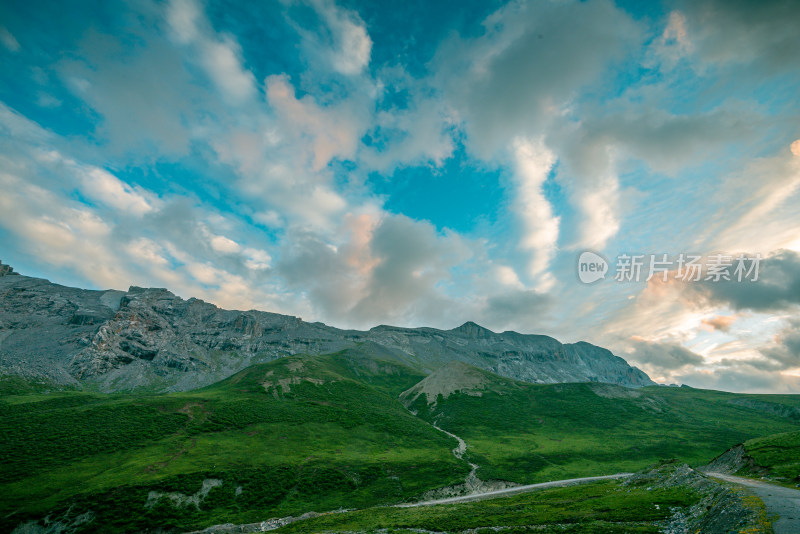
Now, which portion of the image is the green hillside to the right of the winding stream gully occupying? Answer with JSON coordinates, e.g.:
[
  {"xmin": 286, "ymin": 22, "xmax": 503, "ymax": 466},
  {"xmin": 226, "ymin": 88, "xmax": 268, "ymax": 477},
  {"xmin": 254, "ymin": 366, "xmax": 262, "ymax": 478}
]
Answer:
[{"xmin": 409, "ymin": 370, "xmax": 800, "ymax": 484}]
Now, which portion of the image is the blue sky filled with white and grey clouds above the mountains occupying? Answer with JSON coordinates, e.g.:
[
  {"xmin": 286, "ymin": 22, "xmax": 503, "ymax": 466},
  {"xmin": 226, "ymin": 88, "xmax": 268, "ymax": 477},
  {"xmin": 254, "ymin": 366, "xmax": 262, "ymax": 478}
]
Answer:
[{"xmin": 0, "ymin": 0, "xmax": 800, "ymax": 393}]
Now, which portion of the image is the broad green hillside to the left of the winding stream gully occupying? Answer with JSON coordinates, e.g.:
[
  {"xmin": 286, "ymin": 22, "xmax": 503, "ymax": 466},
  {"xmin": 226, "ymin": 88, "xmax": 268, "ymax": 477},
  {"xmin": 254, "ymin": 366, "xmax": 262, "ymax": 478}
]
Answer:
[{"xmin": 0, "ymin": 353, "xmax": 469, "ymax": 532}]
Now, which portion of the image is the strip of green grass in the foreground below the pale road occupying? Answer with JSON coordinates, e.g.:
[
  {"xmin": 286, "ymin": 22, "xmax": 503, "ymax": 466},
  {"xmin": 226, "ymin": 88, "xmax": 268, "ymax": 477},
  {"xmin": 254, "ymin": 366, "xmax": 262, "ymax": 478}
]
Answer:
[{"xmin": 278, "ymin": 481, "xmax": 700, "ymax": 533}]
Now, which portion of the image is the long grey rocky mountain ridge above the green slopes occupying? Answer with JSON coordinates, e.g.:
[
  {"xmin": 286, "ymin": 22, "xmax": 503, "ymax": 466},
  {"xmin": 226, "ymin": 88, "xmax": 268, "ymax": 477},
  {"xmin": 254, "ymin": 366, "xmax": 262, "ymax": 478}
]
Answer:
[{"xmin": 0, "ymin": 273, "xmax": 652, "ymax": 391}]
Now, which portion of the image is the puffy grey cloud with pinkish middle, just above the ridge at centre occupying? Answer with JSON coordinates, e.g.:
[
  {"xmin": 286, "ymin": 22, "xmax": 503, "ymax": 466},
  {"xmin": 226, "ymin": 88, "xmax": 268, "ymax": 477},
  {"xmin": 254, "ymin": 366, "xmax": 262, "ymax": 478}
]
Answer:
[{"xmin": 276, "ymin": 211, "xmax": 478, "ymax": 327}]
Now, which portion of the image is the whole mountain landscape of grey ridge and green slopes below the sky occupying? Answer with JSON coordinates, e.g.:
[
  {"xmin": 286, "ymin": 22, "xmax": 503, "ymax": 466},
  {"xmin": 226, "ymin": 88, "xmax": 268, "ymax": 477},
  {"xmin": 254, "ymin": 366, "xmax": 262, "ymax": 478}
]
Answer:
[{"xmin": 0, "ymin": 275, "xmax": 800, "ymax": 534}]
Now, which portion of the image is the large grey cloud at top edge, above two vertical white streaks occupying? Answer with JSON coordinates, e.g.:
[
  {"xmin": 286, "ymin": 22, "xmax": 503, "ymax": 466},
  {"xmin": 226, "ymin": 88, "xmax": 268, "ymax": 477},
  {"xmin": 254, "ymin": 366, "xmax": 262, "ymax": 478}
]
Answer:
[{"xmin": 433, "ymin": 0, "xmax": 639, "ymax": 158}]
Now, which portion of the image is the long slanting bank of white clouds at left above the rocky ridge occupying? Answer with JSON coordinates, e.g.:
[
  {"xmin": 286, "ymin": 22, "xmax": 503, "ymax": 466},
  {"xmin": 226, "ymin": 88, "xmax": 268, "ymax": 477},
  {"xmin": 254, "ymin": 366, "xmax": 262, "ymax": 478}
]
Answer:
[{"xmin": 0, "ymin": 108, "xmax": 290, "ymax": 313}]
